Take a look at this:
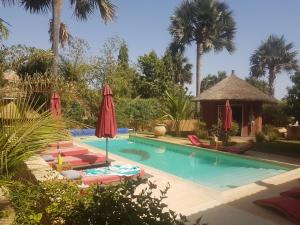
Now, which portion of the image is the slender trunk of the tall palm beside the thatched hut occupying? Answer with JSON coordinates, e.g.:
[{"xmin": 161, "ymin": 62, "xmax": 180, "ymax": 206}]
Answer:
[{"xmin": 196, "ymin": 43, "xmax": 203, "ymax": 117}]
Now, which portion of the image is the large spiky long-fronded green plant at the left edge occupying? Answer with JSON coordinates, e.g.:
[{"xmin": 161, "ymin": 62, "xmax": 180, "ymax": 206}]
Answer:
[{"xmin": 0, "ymin": 93, "xmax": 69, "ymax": 176}]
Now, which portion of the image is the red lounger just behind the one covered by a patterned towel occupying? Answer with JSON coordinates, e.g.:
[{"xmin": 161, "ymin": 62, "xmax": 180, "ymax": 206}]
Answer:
[{"xmin": 49, "ymin": 153, "xmax": 106, "ymax": 168}]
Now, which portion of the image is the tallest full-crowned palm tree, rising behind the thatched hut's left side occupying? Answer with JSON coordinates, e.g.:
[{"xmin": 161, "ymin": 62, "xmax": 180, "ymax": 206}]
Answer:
[{"xmin": 169, "ymin": 0, "xmax": 236, "ymax": 95}]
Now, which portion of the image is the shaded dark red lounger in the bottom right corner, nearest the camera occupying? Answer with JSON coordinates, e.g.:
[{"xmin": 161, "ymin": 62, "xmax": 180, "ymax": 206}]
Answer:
[{"xmin": 254, "ymin": 196, "xmax": 300, "ymax": 224}]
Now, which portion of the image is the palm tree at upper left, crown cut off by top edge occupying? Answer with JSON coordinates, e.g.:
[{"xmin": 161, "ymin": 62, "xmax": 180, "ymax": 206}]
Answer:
[{"xmin": 1, "ymin": 0, "xmax": 115, "ymax": 75}]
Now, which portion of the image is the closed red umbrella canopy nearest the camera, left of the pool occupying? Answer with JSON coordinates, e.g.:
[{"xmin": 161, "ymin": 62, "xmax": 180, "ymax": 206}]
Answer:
[{"xmin": 95, "ymin": 85, "xmax": 117, "ymax": 138}]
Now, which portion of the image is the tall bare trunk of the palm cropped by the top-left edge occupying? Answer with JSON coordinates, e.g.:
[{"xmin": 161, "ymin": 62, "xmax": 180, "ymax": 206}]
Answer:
[{"xmin": 52, "ymin": 0, "xmax": 63, "ymax": 76}]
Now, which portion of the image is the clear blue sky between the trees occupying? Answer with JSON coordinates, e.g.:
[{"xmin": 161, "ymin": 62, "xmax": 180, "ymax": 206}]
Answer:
[{"xmin": 0, "ymin": 0, "xmax": 300, "ymax": 98}]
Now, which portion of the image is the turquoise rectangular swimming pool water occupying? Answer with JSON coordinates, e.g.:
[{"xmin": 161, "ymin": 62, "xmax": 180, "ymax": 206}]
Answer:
[{"xmin": 84, "ymin": 137, "xmax": 291, "ymax": 191}]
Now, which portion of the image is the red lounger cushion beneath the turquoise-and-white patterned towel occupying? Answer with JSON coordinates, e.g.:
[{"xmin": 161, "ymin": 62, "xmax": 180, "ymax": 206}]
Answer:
[{"xmin": 81, "ymin": 170, "xmax": 145, "ymax": 185}]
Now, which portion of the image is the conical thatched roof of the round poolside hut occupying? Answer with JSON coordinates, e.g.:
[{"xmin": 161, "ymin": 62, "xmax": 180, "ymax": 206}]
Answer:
[{"xmin": 194, "ymin": 74, "xmax": 277, "ymax": 103}]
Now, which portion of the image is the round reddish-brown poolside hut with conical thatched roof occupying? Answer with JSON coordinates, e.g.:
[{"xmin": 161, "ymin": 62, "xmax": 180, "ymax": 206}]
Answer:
[{"xmin": 194, "ymin": 71, "xmax": 277, "ymax": 136}]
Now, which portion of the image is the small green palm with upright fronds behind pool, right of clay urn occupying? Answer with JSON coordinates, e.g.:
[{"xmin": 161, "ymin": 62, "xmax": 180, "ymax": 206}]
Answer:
[{"xmin": 163, "ymin": 89, "xmax": 193, "ymax": 136}]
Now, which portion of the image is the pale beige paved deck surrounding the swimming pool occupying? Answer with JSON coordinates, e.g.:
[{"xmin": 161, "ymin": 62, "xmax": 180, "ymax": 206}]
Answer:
[{"xmin": 74, "ymin": 135, "xmax": 300, "ymax": 225}]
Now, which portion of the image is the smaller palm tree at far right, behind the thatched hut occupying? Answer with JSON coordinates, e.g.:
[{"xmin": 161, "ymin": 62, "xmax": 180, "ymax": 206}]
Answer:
[{"xmin": 250, "ymin": 35, "xmax": 298, "ymax": 96}]
